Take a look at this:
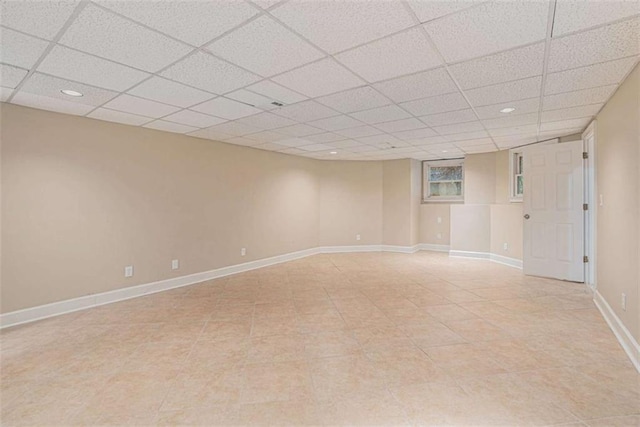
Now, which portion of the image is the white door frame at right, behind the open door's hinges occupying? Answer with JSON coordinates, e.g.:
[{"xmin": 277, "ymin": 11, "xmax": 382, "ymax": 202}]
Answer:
[{"xmin": 582, "ymin": 120, "xmax": 598, "ymax": 292}]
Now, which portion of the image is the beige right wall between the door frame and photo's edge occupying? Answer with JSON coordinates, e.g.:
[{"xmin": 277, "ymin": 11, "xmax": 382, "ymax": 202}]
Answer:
[{"xmin": 596, "ymin": 66, "xmax": 640, "ymax": 341}]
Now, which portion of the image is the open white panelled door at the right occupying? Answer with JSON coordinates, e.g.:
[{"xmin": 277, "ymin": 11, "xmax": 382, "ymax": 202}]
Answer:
[{"xmin": 523, "ymin": 141, "xmax": 584, "ymax": 282}]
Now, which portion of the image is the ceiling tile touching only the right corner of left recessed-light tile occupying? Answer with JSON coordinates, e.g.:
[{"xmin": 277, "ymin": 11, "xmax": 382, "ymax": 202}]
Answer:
[{"xmin": 128, "ymin": 76, "xmax": 215, "ymax": 108}]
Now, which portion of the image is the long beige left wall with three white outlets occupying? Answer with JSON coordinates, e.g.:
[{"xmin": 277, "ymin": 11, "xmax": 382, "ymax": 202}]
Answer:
[{"xmin": 1, "ymin": 104, "xmax": 321, "ymax": 312}]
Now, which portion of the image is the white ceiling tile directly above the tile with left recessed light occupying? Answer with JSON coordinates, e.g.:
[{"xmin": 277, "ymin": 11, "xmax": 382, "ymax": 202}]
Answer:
[{"xmin": 38, "ymin": 46, "xmax": 149, "ymax": 91}]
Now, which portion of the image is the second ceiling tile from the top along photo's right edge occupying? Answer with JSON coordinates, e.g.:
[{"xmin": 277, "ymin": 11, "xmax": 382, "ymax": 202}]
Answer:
[{"xmin": 547, "ymin": 19, "xmax": 640, "ymax": 73}]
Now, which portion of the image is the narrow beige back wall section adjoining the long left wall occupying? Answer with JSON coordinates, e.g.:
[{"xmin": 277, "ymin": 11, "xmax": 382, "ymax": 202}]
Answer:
[{"xmin": 319, "ymin": 161, "xmax": 382, "ymax": 246}]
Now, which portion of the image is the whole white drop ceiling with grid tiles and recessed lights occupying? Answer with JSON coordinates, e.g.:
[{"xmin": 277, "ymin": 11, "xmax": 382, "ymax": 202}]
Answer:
[{"xmin": 0, "ymin": 0, "xmax": 640, "ymax": 160}]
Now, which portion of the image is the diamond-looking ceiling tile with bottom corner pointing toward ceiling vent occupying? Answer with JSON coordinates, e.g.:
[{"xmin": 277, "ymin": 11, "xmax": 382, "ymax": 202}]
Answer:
[{"xmin": 207, "ymin": 16, "xmax": 324, "ymax": 77}]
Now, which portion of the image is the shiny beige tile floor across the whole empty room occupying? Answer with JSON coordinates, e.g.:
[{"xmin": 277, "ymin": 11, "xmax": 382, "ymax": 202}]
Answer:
[{"xmin": 0, "ymin": 252, "xmax": 640, "ymax": 426}]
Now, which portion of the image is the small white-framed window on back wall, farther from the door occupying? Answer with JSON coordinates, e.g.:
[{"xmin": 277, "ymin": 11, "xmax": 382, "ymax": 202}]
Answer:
[{"xmin": 422, "ymin": 159, "xmax": 464, "ymax": 202}]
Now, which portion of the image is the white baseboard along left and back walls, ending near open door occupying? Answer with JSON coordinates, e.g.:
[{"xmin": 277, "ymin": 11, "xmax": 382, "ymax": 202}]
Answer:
[{"xmin": 0, "ymin": 243, "xmax": 522, "ymax": 329}]
